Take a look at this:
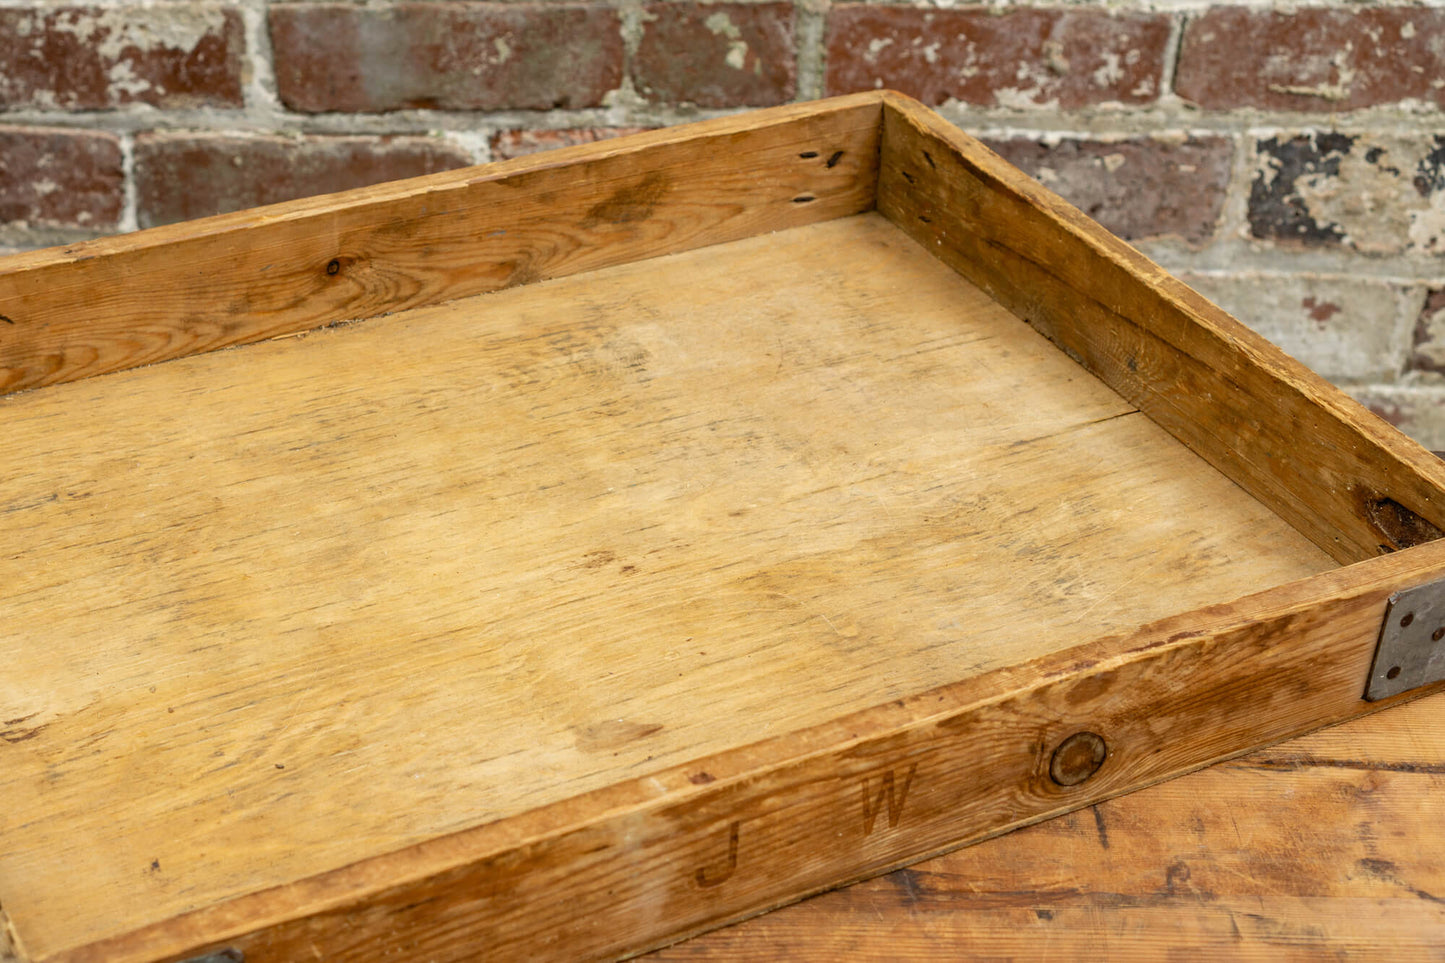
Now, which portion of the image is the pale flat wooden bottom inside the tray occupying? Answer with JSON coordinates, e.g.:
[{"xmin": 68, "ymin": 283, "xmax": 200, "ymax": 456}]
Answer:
[{"xmin": 0, "ymin": 215, "xmax": 1332, "ymax": 959}]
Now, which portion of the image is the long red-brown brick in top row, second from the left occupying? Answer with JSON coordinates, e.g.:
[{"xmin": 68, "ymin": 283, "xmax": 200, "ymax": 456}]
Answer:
[{"xmin": 270, "ymin": 3, "xmax": 623, "ymax": 111}]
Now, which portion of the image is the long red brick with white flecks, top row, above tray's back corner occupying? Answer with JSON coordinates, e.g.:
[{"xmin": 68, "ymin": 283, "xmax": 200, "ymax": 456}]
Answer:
[{"xmin": 827, "ymin": 4, "xmax": 1169, "ymax": 108}]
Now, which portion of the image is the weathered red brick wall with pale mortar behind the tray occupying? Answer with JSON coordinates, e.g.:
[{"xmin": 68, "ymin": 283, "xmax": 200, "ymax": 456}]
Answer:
[{"xmin": 0, "ymin": 0, "xmax": 1445, "ymax": 448}]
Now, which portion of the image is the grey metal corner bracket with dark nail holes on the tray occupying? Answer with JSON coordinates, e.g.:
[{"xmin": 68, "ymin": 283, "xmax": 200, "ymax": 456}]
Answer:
[{"xmin": 1364, "ymin": 569, "xmax": 1445, "ymax": 703}]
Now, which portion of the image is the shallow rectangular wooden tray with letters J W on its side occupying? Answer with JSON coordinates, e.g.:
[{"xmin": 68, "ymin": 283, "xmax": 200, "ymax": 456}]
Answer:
[{"xmin": 0, "ymin": 94, "xmax": 1445, "ymax": 963}]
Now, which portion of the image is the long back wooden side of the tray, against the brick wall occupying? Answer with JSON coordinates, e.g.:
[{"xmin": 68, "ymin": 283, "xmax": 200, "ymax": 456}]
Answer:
[{"xmin": 0, "ymin": 94, "xmax": 880, "ymax": 393}]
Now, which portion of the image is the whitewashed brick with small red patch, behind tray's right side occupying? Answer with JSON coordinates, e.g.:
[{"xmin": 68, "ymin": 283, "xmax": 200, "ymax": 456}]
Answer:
[{"xmin": 1179, "ymin": 272, "xmax": 1418, "ymax": 382}]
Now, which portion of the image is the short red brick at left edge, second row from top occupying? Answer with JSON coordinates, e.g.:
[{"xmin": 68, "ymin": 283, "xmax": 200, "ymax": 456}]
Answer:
[{"xmin": 0, "ymin": 127, "xmax": 124, "ymax": 231}]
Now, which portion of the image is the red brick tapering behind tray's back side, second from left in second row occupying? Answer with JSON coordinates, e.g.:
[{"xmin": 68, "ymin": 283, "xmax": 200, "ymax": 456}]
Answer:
[{"xmin": 136, "ymin": 133, "xmax": 471, "ymax": 227}]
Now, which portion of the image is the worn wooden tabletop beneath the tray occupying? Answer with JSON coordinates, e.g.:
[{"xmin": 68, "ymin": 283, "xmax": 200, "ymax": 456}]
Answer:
[{"xmin": 647, "ymin": 694, "xmax": 1445, "ymax": 963}]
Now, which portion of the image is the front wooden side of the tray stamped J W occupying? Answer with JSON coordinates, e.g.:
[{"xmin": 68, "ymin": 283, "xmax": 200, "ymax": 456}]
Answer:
[{"xmin": 39, "ymin": 542, "xmax": 1445, "ymax": 963}]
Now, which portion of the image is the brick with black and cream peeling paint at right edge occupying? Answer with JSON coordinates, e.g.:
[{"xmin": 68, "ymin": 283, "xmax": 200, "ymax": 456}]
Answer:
[{"xmin": 1248, "ymin": 132, "xmax": 1445, "ymax": 254}]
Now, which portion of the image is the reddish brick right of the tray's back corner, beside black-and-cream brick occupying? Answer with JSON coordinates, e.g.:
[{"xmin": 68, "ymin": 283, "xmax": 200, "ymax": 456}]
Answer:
[{"xmin": 988, "ymin": 137, "xmax": 1234, "ymax": 244}]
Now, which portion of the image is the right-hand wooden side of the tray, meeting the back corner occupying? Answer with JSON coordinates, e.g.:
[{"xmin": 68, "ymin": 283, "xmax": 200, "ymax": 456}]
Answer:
[{"xmin": 879, "ymin": 95, "xmax": 1445, "ymax": 562}]
